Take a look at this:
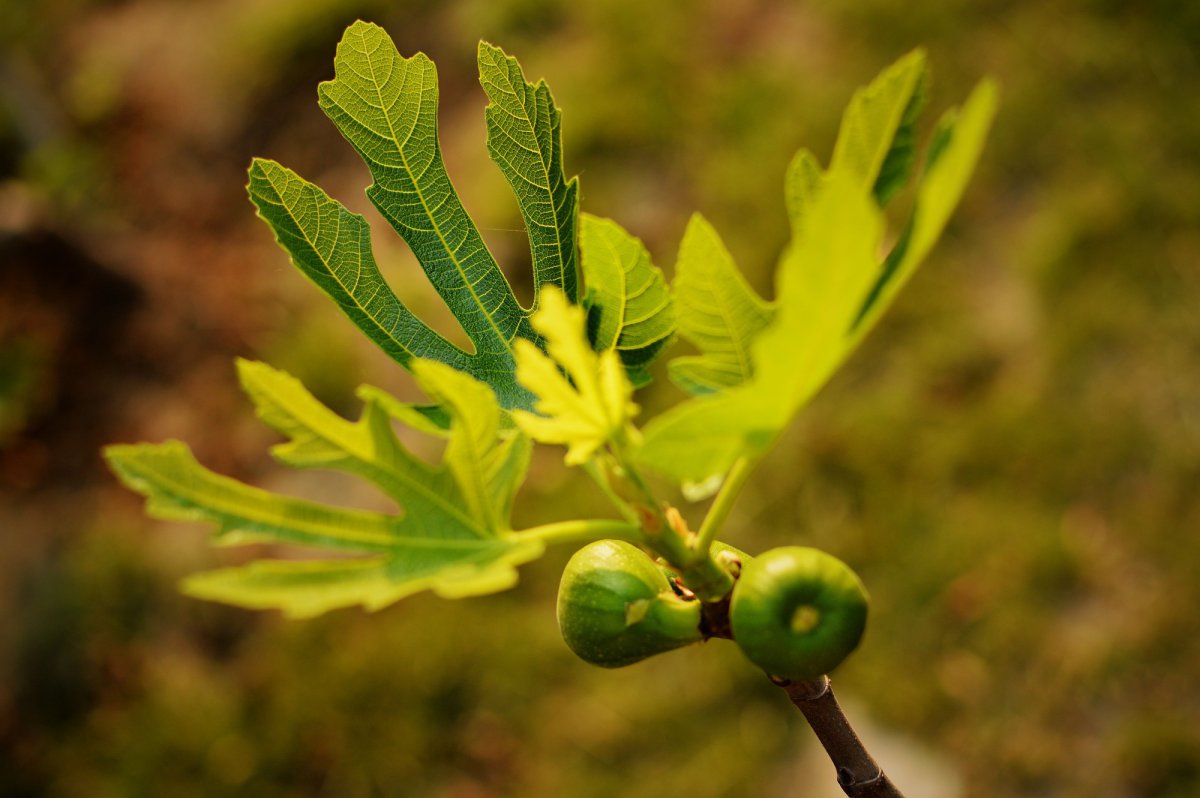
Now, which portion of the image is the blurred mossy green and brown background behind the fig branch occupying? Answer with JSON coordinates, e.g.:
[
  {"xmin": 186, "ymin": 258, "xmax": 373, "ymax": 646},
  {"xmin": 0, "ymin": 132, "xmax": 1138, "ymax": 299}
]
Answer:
[{"xmin": 0, "ymin": 0, "xmax": 1200, "ymax": 798}]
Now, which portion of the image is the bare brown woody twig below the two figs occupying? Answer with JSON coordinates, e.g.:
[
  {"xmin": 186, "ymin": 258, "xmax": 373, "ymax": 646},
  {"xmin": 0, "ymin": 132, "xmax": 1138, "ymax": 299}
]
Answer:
[{"xmin": 772, "ymin": 676, "xmax": 904, "ymax": 798}]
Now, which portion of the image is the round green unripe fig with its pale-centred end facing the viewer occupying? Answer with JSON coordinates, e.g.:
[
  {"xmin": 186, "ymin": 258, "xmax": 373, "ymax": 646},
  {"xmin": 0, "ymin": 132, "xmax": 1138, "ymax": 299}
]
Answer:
[{"xmin": 730, "ymin": 546, "xmax": 866, "ymax": 679}]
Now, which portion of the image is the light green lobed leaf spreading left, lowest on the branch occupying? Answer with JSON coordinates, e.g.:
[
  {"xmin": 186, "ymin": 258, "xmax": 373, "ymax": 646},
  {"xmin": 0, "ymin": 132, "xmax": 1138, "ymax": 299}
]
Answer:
[{"xmin": 106, "ymin": 360, "xmax": 542, "ymax": 616}]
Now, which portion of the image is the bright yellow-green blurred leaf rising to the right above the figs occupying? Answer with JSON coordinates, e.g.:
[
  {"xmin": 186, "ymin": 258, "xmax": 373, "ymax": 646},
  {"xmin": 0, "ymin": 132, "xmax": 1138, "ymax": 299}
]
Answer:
[{"xmin": 637, "ymin": 53, "xmax": 996, "ymax": 482}]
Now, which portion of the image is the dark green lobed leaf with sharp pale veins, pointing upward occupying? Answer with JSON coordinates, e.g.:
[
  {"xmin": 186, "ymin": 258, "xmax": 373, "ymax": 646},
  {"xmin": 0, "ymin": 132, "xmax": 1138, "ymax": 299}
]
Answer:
[{"xmin": 248, "ymin": 22, "xmax": 673, "ymax": 408}]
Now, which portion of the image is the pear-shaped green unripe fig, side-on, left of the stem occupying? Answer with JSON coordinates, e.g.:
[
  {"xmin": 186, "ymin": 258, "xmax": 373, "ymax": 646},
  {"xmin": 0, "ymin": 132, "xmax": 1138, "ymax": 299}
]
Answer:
[{"xmin": 558, "ymin": 540, "xmax": 702, "ymax": 667}]
